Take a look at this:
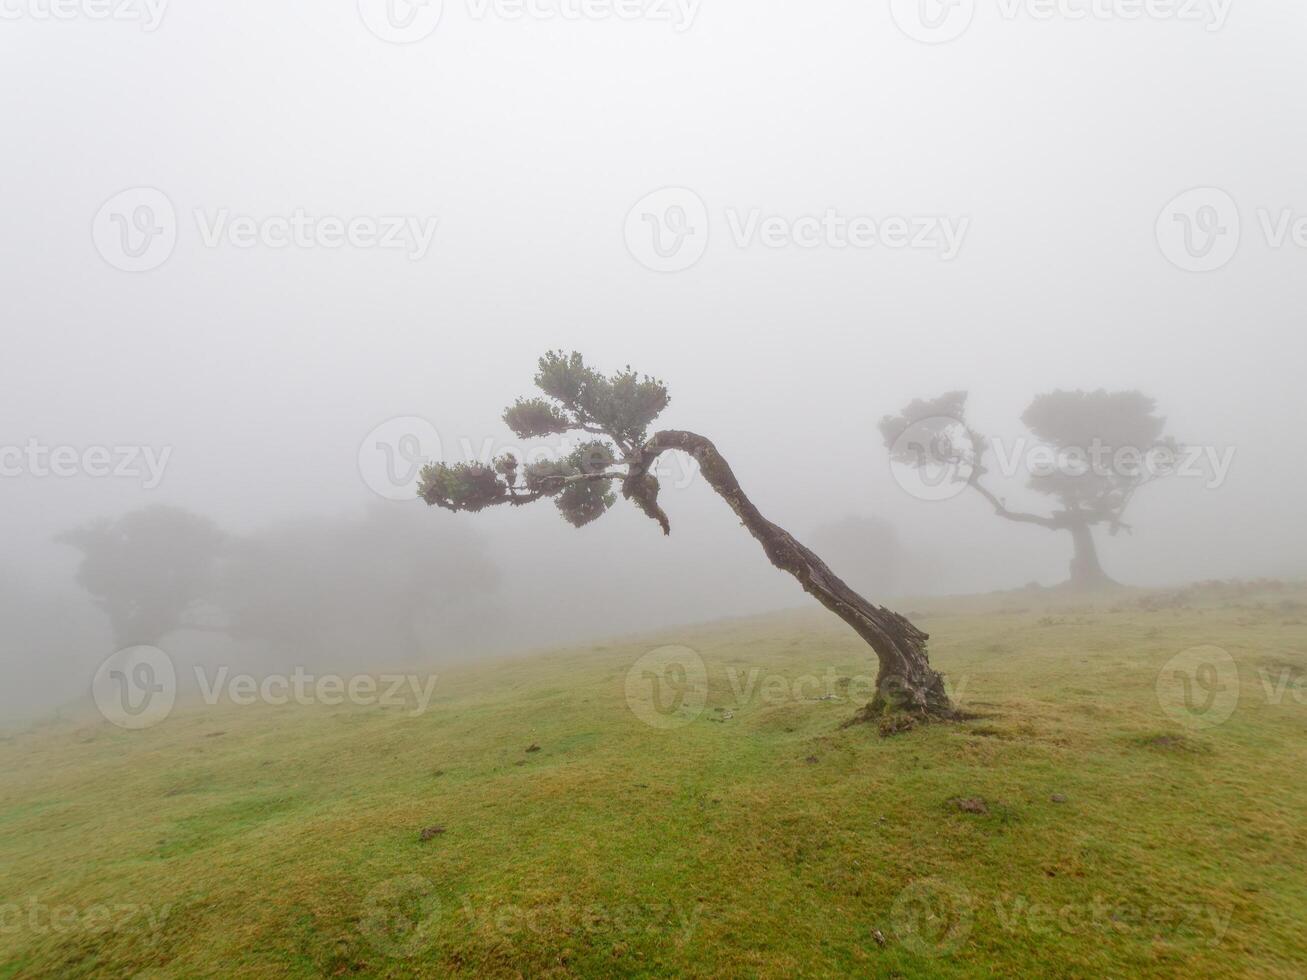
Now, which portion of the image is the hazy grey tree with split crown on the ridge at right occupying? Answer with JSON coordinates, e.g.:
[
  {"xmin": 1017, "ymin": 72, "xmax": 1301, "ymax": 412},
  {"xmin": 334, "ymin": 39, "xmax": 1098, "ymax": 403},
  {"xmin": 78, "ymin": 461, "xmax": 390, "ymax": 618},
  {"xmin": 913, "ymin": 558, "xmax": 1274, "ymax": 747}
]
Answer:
[{"xmin": 880, "ymin": 389, "xmax": 1180, "ymax": 588}]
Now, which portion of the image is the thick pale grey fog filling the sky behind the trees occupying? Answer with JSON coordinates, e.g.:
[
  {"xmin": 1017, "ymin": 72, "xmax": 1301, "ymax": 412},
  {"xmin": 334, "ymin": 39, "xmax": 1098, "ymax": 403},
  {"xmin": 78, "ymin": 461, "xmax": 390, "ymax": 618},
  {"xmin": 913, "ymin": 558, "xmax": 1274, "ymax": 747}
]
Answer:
[{"xmin": 0, "ymin": 0, "xmax": 1307, "ymax": 717}]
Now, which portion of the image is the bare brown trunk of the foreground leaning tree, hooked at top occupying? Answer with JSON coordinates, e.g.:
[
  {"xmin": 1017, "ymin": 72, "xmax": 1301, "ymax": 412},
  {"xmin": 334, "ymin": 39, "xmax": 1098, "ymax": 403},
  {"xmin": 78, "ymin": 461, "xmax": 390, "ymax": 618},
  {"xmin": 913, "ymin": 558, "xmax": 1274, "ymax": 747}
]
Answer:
[{"xmin": 622, "ymin": 430, "xmax": 955, "ymax": 719}]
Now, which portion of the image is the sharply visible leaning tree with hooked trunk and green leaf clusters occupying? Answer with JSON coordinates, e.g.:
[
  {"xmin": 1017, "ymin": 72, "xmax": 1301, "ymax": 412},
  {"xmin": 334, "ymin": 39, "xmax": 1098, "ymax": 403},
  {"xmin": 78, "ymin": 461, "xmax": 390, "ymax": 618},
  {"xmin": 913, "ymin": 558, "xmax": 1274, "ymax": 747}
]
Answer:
[{"xmin": 418, "ymin": 351, "xmax": 954, "ymax": 717}]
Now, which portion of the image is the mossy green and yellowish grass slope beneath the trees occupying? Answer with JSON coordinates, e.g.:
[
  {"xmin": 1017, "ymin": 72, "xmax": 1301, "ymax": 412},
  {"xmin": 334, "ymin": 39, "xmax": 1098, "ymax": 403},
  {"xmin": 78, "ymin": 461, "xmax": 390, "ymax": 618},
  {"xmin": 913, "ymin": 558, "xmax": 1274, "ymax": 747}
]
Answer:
[{"xmin": 0, "ymin": 585, "xmax": 1307, "ymax": 977}]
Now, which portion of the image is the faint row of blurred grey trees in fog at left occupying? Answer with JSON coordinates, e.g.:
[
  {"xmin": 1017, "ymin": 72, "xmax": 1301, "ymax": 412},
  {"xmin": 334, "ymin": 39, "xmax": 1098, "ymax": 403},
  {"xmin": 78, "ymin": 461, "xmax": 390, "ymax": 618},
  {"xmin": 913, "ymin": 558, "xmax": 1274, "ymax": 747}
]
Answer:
[{"xmin": 58, "ymin": 503, "xmax": 499, "ymax": 660}]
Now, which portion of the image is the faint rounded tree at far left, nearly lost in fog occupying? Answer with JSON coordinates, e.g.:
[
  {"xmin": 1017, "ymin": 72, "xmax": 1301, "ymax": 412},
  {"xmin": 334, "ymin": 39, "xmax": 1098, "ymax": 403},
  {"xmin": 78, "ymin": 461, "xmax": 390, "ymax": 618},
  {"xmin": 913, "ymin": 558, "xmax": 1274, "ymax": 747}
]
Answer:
[{"xmin": 56, "ymin": 506, "xmax": 225, "ymax": 647}]
